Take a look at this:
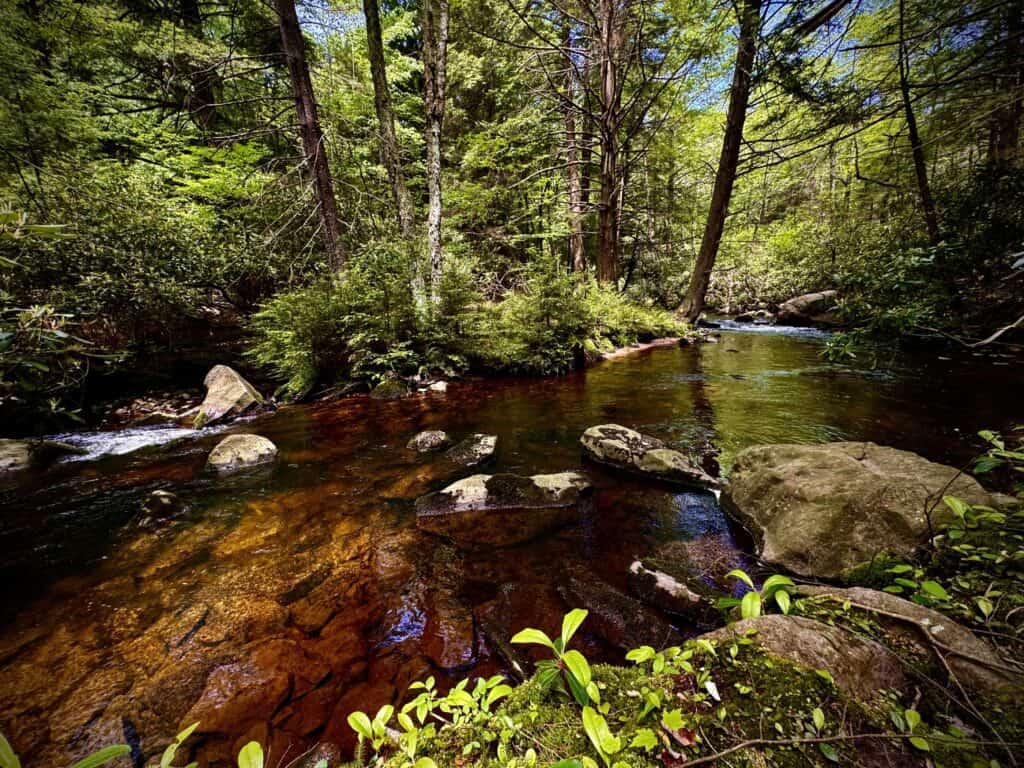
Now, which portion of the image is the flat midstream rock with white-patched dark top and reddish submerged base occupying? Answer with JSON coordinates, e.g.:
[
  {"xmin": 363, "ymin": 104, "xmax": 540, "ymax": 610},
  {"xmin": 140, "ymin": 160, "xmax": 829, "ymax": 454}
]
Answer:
[{"xmin": 416, "ymin": 472, "xmax": 591, "ymax": 547}]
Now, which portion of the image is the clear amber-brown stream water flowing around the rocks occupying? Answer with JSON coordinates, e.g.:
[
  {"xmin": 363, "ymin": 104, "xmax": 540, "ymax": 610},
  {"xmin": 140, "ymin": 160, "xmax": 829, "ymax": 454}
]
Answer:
[{"xmin": 0, "ymin": 324, "xmax": 1024, "ymax": 766}]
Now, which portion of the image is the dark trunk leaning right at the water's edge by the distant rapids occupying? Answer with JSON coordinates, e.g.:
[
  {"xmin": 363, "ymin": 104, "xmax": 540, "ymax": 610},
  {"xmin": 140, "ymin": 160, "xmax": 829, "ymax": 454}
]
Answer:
[{"xmin": 679, "ymin": 0, "xmax": 762, "ymax": 323}]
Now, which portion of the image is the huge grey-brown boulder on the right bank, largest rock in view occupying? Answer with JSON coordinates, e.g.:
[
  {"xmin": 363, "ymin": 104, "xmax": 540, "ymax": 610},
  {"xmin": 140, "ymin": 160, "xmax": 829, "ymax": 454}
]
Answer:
[{"xmin": 722, "ymin": 442, "xmax": 994, "ymax": 579}]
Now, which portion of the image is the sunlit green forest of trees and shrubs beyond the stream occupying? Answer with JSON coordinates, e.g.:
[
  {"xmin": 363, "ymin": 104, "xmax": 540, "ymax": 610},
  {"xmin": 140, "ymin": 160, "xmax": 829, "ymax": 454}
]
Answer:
[{"xmin": 0, "ymin": 0, "xmax": 1024, "ymax": 428}]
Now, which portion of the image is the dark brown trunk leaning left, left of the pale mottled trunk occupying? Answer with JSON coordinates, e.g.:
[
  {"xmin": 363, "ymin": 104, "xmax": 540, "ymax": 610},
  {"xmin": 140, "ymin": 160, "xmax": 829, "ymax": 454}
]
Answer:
[{"xmin": 274, "ymin": 0, "xmax": 345, "ymax": 270}]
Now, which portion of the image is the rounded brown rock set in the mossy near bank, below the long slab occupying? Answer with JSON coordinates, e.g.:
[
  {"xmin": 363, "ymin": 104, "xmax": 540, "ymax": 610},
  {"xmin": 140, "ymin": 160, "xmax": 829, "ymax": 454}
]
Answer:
[{"xmin": 705, "ymin": 614, "xmax": 907, "ymax": 701}]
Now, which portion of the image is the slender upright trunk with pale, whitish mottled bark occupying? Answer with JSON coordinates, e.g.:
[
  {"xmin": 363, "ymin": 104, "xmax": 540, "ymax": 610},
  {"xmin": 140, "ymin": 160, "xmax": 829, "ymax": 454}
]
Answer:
[{"xmin": 422, "ymin": 0, "xmax": 449, "ymax": 299}]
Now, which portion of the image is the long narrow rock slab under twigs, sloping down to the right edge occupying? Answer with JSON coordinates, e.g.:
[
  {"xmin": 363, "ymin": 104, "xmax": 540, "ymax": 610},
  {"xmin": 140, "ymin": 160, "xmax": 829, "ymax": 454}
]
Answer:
[{"xmin": 797, "ymin": 585, "xmax": 1024, "ymax": 692}]
